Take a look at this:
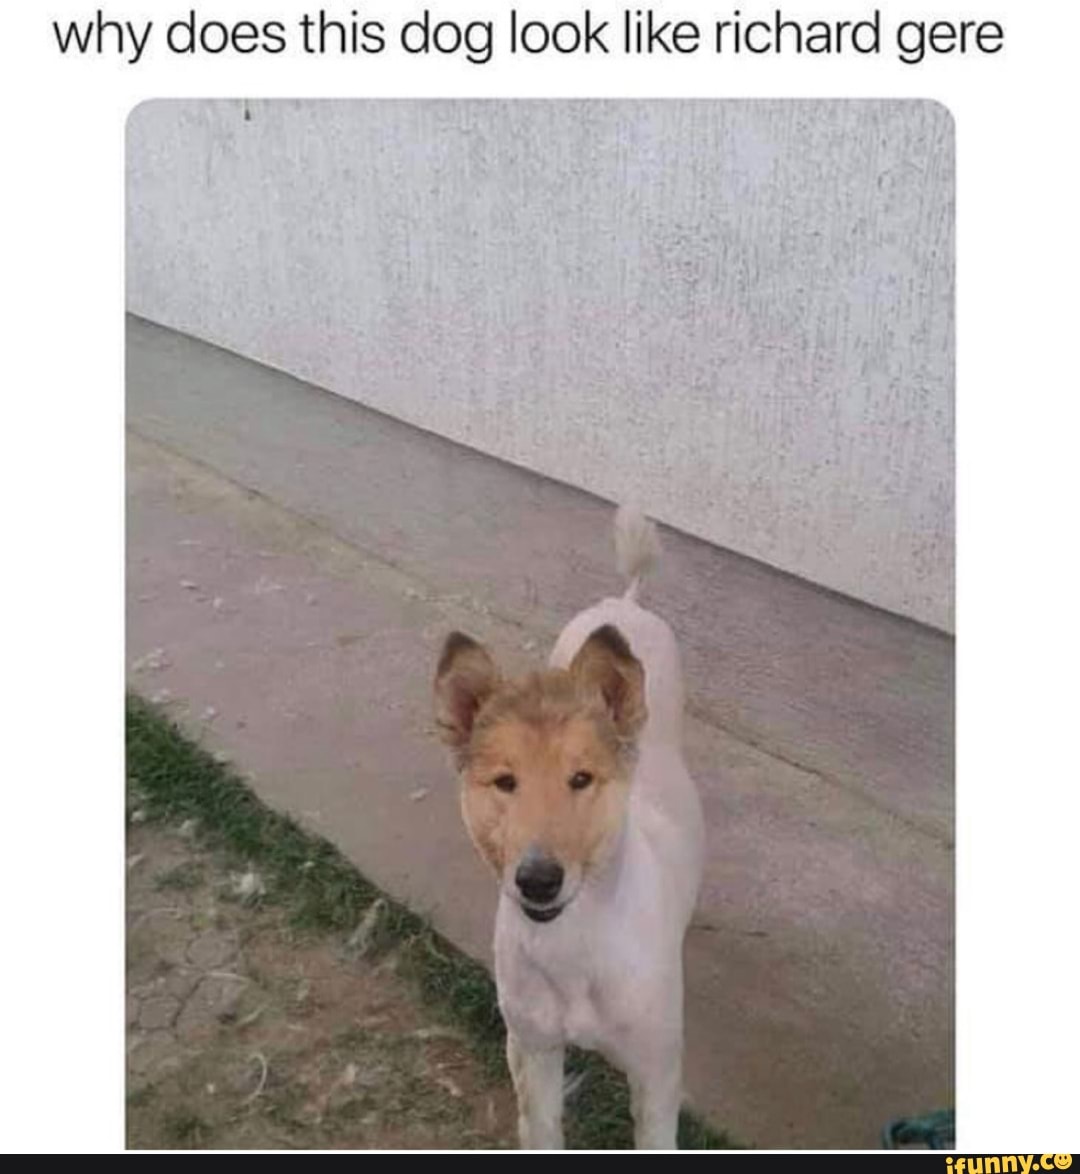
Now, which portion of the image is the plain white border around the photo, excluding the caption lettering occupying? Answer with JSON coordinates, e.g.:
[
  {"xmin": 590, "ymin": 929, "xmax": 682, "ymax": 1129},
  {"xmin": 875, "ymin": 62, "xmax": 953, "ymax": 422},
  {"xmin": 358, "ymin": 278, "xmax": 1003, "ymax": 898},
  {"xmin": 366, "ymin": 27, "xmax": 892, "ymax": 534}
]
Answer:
[{"xmin": 0, "ymin": 0, "xmax": 1080, "ymax": 1153}]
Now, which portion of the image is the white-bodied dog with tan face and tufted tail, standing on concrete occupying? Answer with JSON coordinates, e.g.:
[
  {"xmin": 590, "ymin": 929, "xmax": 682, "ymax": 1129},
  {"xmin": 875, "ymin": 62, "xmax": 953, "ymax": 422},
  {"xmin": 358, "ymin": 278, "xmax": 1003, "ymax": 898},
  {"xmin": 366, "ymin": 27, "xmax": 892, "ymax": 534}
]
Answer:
[{"xmin": 434, "ymin": 507, "xmax": 704, "ymax": 1149}]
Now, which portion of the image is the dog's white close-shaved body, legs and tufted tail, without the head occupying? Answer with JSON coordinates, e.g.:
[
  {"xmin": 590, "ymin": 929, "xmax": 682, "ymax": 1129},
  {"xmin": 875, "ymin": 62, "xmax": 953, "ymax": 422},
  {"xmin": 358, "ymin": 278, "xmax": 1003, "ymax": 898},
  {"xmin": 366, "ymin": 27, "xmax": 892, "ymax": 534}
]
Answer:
[{"xmin": 495, "ymin": 511, "xmax": 704, "ymax": 1149}]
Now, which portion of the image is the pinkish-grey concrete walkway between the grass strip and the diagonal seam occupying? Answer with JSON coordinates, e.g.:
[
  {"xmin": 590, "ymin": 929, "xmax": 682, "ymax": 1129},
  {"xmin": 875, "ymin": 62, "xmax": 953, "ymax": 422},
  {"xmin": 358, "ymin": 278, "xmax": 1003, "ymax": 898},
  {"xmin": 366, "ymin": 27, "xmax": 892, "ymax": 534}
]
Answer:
[{"xmin": 128, "ymin": 326, "xmax": 953, "ymax": 1148}]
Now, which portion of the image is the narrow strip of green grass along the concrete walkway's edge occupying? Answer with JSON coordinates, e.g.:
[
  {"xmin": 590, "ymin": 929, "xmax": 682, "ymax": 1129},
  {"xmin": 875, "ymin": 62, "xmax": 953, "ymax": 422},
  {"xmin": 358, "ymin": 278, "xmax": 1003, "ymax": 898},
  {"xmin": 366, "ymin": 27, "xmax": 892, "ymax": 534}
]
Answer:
[{"xmin": 127, "ymin": 695, "xmax": 735, "ymax": 1149}]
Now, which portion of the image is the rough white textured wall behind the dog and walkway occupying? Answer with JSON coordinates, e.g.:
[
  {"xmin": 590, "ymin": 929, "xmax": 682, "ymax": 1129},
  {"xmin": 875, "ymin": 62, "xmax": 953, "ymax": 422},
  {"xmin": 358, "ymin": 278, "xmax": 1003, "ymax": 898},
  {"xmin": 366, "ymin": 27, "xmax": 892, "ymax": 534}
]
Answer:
[{"xmin": 128, "ymin": 101, "xmax": 953, "ymax": 629}]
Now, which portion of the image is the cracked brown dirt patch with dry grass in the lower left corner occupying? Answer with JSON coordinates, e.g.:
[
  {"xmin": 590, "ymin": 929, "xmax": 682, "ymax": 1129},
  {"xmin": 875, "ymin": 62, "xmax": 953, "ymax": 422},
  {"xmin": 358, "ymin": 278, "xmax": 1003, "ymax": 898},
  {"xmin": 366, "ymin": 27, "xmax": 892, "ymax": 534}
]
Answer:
[{"xmin": 127, "ymin": 824, "xmax": 515, "ymax": 1149}]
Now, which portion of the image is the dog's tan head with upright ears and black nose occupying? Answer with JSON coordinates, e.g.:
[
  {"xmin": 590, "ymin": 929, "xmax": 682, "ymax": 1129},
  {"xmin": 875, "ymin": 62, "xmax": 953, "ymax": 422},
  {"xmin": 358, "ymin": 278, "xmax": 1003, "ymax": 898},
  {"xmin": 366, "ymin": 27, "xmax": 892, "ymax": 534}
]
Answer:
[{"xmin": 436, "ymin": 626, "xmax": 646, "ymax": 922}]
